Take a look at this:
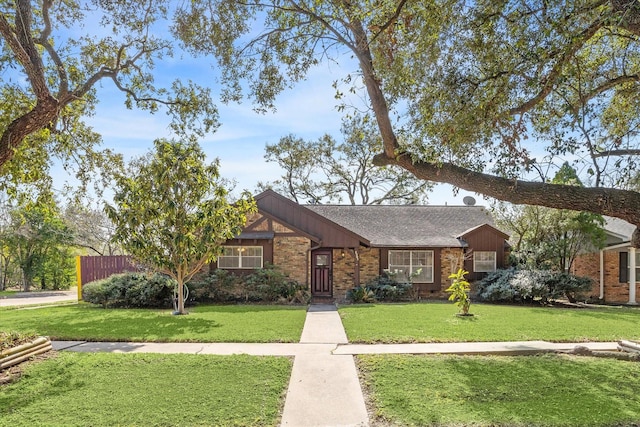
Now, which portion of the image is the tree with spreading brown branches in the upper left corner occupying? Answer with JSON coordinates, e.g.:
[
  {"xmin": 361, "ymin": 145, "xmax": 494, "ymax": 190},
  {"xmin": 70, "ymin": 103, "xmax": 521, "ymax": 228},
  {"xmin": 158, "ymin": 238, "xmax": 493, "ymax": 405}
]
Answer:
[{"xmin": 0, "ymin": 0, "xmax": 217, "ymax": 198}]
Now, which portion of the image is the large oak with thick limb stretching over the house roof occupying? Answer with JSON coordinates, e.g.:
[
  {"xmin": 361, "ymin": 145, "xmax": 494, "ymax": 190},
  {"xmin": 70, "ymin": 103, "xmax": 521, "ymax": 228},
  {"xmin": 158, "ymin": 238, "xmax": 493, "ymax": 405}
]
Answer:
[{"xmin": 176, "ymin": 0, "xmax": 640, "ymax": 246}]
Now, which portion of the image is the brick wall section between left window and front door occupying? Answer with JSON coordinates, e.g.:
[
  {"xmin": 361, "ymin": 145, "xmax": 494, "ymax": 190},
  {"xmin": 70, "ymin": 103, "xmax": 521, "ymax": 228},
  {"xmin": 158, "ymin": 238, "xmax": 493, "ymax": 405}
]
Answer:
[{"xmin": 273, "ymin": 235, "xmax": 311, "ymax": 285}]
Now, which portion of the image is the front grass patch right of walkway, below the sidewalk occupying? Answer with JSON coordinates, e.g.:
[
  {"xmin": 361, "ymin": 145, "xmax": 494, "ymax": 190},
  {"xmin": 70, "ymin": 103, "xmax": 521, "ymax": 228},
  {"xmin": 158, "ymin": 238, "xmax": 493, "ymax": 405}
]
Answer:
[{"xmin": 358, "ymin": 355, "xmax": 640, "ymax": 427}]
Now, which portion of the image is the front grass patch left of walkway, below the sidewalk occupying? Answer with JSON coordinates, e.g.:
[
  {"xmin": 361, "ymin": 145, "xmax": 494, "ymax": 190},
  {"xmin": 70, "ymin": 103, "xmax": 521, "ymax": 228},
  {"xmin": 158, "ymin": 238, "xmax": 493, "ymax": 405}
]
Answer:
[{"xmin": 0, "ymin": 352, "xmax": 292, "ymax": 427}]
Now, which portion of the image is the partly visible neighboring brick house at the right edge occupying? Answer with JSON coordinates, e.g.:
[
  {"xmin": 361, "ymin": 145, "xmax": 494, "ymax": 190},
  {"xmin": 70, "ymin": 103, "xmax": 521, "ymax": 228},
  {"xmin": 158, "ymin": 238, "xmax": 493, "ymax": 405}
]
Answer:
[{"xmin": 572, "ymin": 217, "xmax": 640, "ymax": 304}]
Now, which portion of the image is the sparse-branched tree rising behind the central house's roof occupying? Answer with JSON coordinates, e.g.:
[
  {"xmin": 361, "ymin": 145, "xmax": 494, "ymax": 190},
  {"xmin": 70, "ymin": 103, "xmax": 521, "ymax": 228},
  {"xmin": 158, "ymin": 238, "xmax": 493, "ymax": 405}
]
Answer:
[{"xmin": 260, "ymin": 115, "xmax": 431, "ymax": 205}]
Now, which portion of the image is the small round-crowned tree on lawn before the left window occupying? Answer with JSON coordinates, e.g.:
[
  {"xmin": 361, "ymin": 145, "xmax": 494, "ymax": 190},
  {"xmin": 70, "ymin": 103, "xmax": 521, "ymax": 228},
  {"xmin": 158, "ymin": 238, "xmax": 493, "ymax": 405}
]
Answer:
[{"xmin": 105, "ymin": 139, "xmax": 256, "ymax": 314}]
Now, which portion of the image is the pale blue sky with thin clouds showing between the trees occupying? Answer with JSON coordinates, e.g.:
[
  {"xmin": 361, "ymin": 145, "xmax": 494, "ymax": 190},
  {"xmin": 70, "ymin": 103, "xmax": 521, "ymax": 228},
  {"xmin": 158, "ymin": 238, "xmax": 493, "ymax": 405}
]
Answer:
[{"xmin": 54, "ymin": 20, "xmax": 488, "ymax": 205}]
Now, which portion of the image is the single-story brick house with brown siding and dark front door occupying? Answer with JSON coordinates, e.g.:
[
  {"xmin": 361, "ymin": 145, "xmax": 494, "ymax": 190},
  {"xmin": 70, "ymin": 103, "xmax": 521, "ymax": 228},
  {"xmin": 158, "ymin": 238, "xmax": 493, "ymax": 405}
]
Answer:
[{"xmin": 212, "ymin": 190, "xmax": 508, "ymax": 300}]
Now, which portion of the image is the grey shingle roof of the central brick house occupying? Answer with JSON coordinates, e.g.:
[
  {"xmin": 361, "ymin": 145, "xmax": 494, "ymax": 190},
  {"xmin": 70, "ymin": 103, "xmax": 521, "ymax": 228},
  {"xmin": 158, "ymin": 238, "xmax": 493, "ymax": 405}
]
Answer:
[{"xmin": 305, "ymin": 205, "xmax": 495, "ymax": 247}]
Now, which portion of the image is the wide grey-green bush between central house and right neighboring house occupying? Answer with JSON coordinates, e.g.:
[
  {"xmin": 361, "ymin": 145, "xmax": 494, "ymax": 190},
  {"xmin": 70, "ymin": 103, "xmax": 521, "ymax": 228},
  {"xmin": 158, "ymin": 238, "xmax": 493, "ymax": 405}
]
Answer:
[{"xmin": 475, "ymin": 268, "xmax": 591, "ymax": 303}]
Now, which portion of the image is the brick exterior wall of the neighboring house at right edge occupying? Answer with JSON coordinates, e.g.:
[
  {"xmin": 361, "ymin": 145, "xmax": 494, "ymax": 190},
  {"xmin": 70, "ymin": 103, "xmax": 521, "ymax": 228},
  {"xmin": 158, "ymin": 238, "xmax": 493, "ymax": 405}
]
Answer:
[{"xmin": 572, "ymin": 251, "xmax": 640, "ymax": 303}]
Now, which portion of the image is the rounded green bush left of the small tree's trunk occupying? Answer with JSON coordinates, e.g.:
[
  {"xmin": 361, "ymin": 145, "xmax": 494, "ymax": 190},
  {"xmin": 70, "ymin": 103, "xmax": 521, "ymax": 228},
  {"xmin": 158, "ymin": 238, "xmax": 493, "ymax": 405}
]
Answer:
[{"xmin": 82, "ymin": 273, "xmax": 175, "ymax": 308}]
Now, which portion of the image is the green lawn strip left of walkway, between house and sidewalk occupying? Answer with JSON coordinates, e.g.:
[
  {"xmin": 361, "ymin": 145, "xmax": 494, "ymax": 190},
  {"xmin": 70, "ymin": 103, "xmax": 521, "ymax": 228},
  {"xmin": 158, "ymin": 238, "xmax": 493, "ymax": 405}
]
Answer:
[{"xmin": 0, "ymin": 304, "xmax": 306, "ymax": 342}]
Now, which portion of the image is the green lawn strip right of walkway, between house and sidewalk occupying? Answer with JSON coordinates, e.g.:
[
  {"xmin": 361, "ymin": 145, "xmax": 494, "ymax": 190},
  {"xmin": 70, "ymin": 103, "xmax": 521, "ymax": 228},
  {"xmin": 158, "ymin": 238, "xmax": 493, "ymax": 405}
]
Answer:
[{"xmin": 340, "ymin": 303, "xmax": 640, "ymax": 342}]
